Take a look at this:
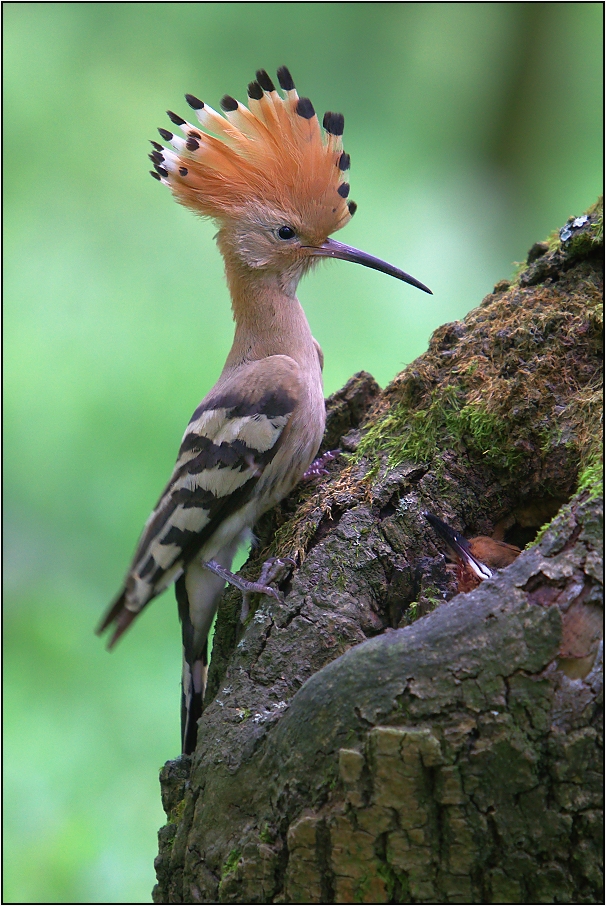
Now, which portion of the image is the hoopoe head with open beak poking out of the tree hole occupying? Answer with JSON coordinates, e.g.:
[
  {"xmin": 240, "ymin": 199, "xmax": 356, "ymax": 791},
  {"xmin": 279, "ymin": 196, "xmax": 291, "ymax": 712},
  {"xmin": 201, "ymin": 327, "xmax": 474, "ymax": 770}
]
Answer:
[{"xmin": 423, "ymin": 513, "xmax": 522, "ymax": 592}]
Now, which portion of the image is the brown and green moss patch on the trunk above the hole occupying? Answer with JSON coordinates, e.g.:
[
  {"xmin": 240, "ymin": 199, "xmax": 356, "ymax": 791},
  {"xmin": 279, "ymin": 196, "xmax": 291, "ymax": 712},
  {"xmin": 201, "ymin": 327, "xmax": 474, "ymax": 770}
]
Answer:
[{"xmin": 354, "ymin": 203, "xmax": 603, "ymax": 492}]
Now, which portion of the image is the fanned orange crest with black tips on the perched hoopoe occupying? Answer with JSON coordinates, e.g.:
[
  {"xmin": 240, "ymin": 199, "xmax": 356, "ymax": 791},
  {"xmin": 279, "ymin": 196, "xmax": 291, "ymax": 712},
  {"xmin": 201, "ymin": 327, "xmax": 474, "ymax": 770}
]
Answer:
[{"xmin": 150, "ymin": 66, "xmax": 356, "ymax": 236}]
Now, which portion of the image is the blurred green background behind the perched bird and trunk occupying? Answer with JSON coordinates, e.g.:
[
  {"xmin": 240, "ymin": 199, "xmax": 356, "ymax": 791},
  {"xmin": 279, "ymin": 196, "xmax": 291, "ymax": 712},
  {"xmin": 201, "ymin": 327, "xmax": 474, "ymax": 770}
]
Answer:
[{"xmin": 3, "ymin": 3, "xmax": 602, "ymax": 903}]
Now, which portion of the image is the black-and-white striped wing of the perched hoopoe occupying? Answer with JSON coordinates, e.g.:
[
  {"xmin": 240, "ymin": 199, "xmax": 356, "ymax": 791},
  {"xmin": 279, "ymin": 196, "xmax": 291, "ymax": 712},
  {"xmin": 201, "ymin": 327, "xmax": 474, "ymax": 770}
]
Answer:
[{"xmin": 98, "ymin": 356, "xmax": 300, "ymax": 647}]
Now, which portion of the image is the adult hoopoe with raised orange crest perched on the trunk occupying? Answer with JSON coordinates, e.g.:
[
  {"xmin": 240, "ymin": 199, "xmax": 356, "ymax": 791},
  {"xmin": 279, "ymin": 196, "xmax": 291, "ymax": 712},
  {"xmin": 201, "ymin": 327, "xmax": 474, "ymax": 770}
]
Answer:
[{"xmin": 98, "ymin": 67, "xmax": 431, "ymax": 754}]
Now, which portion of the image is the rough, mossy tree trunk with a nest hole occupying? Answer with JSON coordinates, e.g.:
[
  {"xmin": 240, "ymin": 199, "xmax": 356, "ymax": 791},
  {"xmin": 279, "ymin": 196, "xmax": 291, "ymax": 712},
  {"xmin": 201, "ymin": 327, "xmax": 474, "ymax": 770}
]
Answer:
[{"xmin": 154, "ymin": 196, "xmax": 603, "ymax": 903}]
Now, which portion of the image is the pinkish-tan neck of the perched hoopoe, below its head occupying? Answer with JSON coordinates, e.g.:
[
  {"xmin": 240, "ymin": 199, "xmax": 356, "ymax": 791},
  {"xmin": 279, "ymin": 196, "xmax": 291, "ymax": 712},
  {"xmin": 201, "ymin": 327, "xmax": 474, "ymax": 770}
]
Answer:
[{"xmin": 226, "ymin": 256, "xmax": 318, "ymax": 367}]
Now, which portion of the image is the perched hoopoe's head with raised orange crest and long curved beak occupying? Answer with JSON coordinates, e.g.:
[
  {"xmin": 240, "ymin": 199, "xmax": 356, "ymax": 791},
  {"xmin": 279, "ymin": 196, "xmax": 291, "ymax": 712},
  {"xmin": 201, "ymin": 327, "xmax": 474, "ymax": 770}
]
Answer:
[{"xmin": 150, "ymin": 66, "xmax": 431, "ymax": 292}]
